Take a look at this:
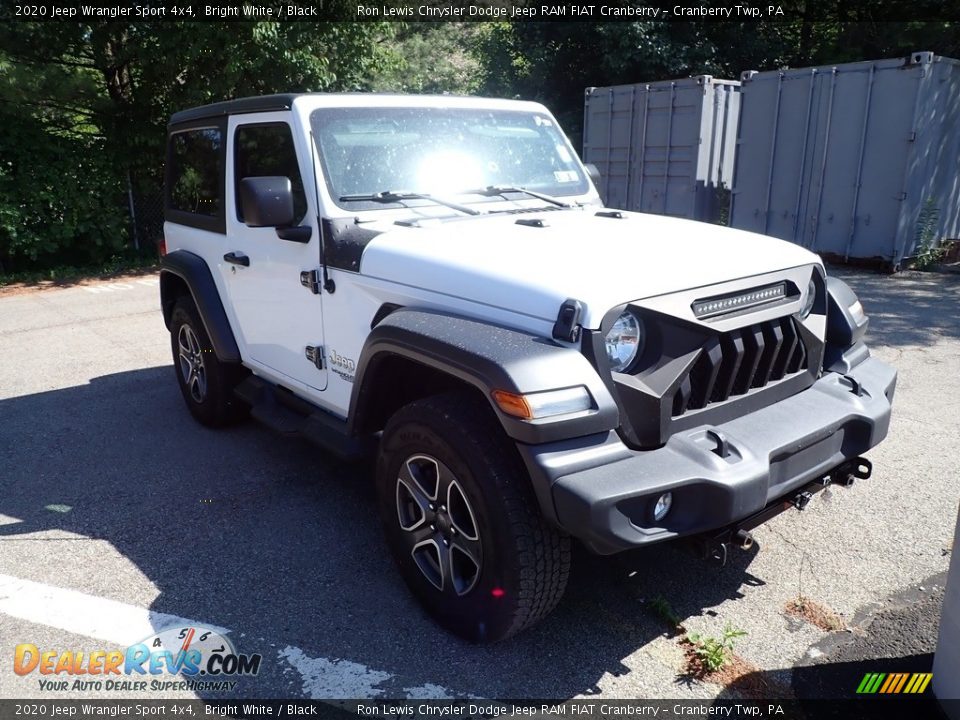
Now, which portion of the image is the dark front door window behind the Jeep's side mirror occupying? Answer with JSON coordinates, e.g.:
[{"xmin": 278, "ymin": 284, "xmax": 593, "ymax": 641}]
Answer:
[{"xmin": 233, "ymin": 123, "xmax": 307, "ymax": 224}]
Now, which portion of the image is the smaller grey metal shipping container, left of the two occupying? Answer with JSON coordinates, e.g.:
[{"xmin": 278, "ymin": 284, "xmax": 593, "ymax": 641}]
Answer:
[{"xmin": 583, "ymin": 75, "xmax": 740, "ymax": 221}]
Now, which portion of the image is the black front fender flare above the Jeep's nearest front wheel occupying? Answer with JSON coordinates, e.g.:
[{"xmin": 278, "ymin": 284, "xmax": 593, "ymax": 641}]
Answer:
[{"xmin": 348, "ymin": 308, "xmax": 620, "ymax": 444}]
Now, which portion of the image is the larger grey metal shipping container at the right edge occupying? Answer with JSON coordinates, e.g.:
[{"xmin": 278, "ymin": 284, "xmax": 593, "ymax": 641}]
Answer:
[{"xmin": 730, "ymin": 52, "xmax": 960, "ymax": 269}]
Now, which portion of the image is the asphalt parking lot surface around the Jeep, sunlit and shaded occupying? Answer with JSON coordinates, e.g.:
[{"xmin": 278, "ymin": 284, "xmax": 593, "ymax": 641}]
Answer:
[{"xmin": 0, "ymin": 270, "xmax": 960, "ymax": 699}]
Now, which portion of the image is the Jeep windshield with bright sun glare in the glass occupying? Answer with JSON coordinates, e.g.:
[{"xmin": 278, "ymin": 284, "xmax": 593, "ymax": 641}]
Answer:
[{"xmin": 310, "ymin": 107, "xmax": 588, "ymax": 211}]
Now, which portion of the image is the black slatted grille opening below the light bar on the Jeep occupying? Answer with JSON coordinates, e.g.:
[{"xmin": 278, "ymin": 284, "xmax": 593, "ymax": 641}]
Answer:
[{"xmin": 673, "ymin": 317, "xmax": 808, "ymax": 417}]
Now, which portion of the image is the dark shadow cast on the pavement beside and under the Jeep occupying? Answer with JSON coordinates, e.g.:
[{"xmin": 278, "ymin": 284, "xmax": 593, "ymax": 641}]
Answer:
[{"xmin": 0, "ymin": 366, "xmax": 763, "ymax": 698}]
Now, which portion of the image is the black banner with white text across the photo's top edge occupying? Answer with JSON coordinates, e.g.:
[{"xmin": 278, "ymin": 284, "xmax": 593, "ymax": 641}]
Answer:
[{"xmin": 0, "ymin": 0, "xmax": 960, "ymax": 23}]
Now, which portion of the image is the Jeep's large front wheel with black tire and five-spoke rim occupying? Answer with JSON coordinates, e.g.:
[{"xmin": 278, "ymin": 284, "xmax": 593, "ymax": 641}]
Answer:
[{"xmin": 376, "ymin": 394, "xmax": 570, "ymax": 642}]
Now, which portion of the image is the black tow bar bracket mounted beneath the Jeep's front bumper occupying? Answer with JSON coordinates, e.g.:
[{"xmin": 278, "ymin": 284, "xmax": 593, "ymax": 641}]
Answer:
[{"xmin": 691, "ymin": 457, "xmax": 873, "ymax": 565}]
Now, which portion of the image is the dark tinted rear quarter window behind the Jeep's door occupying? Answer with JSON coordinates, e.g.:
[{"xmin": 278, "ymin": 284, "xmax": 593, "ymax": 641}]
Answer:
[{"xmin": 168, "ymin": 128, "xmax": 223, "ymax": 218}]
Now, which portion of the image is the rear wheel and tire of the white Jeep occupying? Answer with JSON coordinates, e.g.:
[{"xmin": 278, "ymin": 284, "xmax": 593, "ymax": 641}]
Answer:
[{"xmin": 170, "ymin": 295, "xmax": 249, "ymax": 427}]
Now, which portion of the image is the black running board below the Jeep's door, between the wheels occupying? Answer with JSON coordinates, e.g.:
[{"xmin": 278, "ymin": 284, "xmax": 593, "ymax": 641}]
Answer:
[{"xmin": 234, "ymin": 375, "xmax": 376, "ymax": 462}]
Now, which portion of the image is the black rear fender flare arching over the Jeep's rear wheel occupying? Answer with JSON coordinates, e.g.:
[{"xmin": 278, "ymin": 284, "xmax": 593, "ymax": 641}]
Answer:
[{"xmin": 160, "ymin": 250, "xmax": 240, "ymax": 363}]
